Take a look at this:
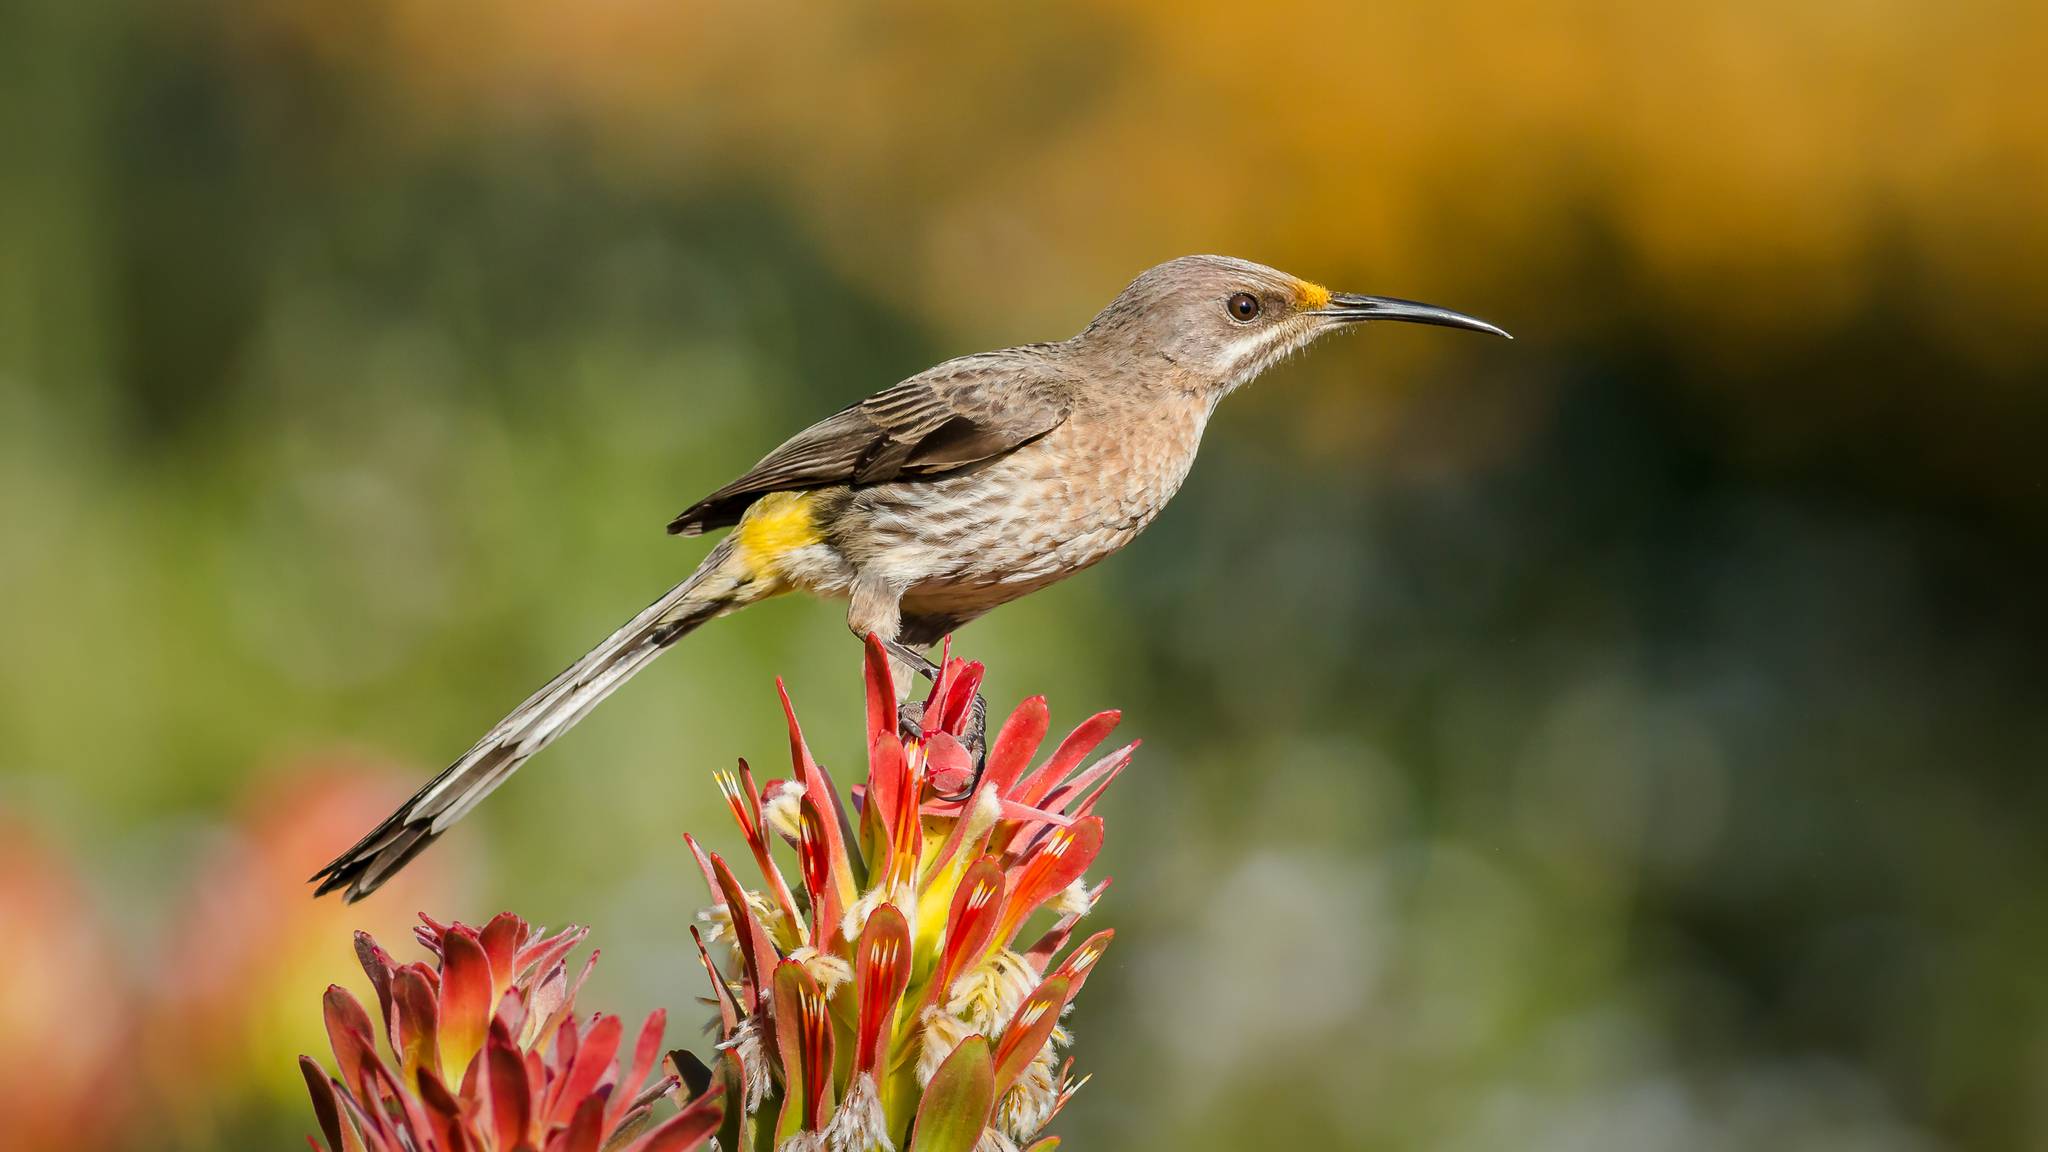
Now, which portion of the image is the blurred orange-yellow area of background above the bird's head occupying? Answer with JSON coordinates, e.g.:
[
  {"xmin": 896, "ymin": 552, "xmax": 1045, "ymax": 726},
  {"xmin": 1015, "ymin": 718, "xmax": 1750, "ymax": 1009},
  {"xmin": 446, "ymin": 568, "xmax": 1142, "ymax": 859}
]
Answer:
[{"xmin": 233, "ymin": 0, "xmax": 2048, "ymax": 344}]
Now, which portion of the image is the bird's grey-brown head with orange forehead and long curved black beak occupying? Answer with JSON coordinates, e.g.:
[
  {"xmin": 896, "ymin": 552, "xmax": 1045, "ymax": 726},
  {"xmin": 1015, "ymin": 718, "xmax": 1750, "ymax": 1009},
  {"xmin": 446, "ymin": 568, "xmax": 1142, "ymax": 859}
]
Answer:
[{"xmin": 1075, "ymin": 256, "xmax": 1511, "ymax": 396}]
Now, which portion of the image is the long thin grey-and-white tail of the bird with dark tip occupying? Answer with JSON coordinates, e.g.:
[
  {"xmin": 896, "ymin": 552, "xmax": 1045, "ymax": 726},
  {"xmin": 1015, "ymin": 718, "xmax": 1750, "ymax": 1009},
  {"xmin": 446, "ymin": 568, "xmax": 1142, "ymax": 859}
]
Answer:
[{"xmin": 313, "ymin": 539, "xmax": 768, "ymax": 902}]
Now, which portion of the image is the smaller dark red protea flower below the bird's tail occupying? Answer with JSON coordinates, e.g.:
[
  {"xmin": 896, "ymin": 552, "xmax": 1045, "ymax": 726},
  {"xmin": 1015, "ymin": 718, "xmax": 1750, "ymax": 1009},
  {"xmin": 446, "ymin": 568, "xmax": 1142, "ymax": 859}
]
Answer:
[{"xmin": 299, "ymin": 912, "xmax": 723, "ymax": 1152}]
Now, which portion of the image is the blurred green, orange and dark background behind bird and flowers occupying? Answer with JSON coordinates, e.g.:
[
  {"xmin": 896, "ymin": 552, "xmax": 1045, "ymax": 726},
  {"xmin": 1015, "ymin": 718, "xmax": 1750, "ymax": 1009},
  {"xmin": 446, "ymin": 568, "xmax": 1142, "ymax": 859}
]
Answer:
[{"xmin": 0, "ymin": 0, "xmax": 2048, "ymax": 1152}]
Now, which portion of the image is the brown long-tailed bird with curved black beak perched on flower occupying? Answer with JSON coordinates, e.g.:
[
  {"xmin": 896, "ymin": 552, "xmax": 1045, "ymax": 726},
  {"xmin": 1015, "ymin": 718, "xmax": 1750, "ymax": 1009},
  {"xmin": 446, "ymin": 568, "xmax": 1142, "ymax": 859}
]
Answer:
[{"xmin": 311, "ymin": 256, "xmax": 1511, "ymax": 902}]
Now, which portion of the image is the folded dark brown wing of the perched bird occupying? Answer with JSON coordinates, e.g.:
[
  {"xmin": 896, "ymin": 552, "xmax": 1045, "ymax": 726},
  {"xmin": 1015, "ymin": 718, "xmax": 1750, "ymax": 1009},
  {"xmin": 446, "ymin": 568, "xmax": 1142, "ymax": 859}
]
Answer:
[{"xmin": 668, "ymin": 348, "xmax": 1071, "ymax": 535}]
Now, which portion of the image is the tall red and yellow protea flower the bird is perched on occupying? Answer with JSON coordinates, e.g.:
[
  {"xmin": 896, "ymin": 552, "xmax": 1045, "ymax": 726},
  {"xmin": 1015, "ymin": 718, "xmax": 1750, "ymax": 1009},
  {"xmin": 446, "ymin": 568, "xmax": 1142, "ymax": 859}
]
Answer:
[{"xmin": 688, "ymin": 637, "xmax": 1135, "ymax": 1152}]
